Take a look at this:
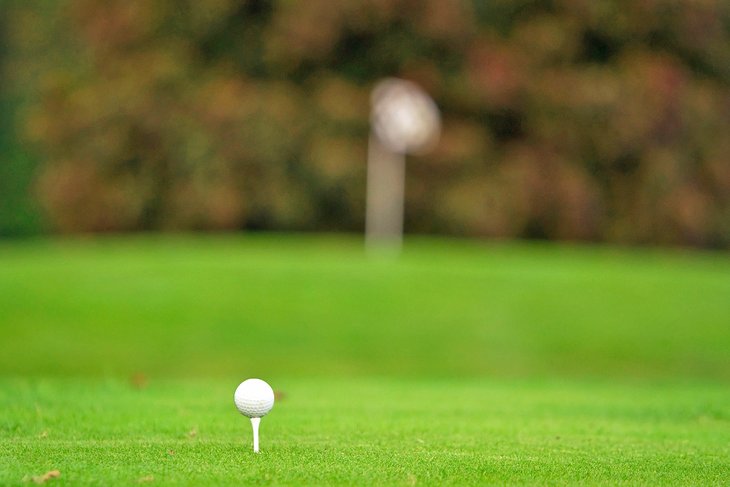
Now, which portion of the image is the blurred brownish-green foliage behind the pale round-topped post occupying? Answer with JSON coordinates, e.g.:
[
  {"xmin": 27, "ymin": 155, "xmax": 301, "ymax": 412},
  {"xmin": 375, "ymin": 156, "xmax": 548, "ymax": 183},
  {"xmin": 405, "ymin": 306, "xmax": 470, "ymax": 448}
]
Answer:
[{"xmin": 0, "ymin": 0, "xmax": 730, "ymax": 248}]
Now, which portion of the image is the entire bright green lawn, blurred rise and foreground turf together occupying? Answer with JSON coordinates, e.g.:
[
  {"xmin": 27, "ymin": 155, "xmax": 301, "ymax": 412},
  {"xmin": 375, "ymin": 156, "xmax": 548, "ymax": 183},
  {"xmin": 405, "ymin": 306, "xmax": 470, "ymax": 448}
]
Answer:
[{"xmin": 0, "ymin": 235, "xmax": 730, "ymax": 485}]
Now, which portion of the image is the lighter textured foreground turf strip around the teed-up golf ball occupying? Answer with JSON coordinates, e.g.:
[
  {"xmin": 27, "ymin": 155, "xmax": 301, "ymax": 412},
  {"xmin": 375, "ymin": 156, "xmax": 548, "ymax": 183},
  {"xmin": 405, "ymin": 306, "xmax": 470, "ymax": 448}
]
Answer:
[{"xmin": 0, "ymin": 379, "xmax": 730, "ymax": 485}]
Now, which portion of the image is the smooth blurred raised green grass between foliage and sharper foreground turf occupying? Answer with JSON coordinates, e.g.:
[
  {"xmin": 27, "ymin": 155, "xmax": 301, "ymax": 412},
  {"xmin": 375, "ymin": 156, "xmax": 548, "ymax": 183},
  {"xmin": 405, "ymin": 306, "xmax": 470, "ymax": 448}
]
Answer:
[{"xmin": 0, "ymin": 237, "xmax": 730, "ymax": 379}]
